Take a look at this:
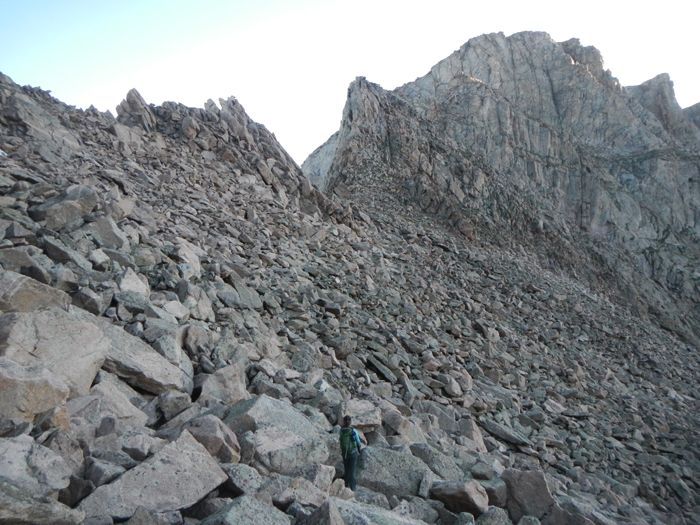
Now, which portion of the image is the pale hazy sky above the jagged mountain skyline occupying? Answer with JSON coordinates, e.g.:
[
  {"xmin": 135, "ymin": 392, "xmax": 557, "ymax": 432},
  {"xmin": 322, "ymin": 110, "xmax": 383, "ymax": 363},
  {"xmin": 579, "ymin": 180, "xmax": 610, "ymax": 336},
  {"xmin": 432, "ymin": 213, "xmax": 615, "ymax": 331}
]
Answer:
[{"xmin": 0, "ymin": 0, "xmax": 700, "ymax": 164}]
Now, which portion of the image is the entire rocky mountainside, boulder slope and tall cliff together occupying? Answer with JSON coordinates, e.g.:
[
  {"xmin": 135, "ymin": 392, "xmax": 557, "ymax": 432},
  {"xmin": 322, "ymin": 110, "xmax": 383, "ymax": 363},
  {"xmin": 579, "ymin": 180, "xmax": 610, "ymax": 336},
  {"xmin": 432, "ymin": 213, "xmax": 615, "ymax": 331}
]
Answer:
[{"xmin": 0, "ymin": 33, "xmax": 700, "ymax": 525}]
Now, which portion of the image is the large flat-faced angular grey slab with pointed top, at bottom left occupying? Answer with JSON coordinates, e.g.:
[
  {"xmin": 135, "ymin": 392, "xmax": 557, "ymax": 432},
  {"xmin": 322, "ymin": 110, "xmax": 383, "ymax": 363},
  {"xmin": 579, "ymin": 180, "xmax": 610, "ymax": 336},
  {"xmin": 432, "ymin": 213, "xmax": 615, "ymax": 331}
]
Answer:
[{"xmin": 78, "ymin": 431, "xmax": 227, "ymax": 519}]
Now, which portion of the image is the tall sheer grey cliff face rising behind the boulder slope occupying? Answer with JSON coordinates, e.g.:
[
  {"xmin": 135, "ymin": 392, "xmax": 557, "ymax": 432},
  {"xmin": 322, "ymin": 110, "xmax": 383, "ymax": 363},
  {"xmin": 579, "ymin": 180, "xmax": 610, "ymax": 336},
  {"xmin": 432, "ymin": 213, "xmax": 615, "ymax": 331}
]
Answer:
[{"xmin": 303, "ymin": 32, "xmax": 700, "ymax": 340}]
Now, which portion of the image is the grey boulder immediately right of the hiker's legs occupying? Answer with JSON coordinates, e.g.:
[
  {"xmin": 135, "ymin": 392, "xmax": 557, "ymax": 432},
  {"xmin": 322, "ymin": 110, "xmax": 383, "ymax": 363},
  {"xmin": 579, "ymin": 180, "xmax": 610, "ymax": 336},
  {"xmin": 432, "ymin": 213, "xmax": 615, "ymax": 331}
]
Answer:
[{"xmin": 357, "ymin": 447, "xmax": 430, "ymax": 497}]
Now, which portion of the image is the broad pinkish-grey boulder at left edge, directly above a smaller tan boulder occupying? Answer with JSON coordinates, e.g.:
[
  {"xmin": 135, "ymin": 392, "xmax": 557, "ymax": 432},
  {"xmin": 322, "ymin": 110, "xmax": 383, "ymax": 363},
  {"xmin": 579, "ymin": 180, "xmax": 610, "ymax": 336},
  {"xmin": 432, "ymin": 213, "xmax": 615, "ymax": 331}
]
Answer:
[{"xmin": 0, "ymin": 308, "xmax": 110, "ymax": 397}]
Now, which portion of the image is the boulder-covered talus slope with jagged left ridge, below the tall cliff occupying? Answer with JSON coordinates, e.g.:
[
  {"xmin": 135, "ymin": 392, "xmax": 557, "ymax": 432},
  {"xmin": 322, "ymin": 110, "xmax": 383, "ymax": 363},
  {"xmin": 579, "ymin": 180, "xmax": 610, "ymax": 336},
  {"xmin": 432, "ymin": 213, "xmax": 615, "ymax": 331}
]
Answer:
[{"xmin": 0, "ymin": 57, "xmax": 700, "ymax": 525}]
